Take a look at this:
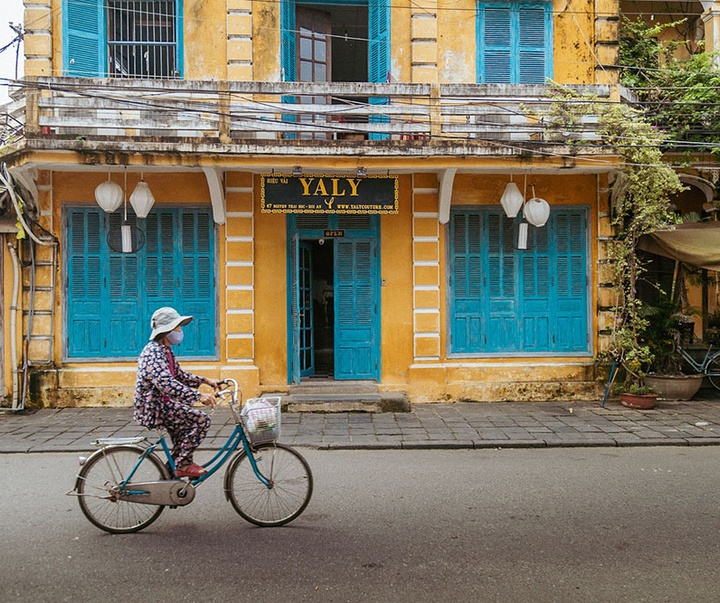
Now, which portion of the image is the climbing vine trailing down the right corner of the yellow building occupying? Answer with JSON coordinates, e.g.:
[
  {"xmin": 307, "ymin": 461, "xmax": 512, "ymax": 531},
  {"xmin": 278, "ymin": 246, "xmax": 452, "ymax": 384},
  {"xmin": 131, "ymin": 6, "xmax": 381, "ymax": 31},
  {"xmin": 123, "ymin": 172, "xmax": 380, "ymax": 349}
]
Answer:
[{"xmin": 547, "ymin": 85, "xmax": 684, "ymax": 390}]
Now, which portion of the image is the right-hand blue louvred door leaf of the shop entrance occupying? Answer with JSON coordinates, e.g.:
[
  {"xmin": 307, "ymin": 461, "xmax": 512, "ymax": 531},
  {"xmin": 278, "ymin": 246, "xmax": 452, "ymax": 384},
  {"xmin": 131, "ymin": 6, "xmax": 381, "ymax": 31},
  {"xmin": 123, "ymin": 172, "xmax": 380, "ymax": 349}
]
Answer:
[{"xmin": 335, "ymin": 239, "xmax": 378, "ymax": 379}]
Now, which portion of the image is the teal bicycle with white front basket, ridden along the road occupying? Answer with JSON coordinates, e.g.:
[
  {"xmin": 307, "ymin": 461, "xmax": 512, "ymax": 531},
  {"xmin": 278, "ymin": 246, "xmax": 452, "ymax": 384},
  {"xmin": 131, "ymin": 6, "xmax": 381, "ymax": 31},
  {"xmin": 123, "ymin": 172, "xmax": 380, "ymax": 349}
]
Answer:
[{"xmin": 68, "ymin": 379, "xmax": 313, "ymax": 534}]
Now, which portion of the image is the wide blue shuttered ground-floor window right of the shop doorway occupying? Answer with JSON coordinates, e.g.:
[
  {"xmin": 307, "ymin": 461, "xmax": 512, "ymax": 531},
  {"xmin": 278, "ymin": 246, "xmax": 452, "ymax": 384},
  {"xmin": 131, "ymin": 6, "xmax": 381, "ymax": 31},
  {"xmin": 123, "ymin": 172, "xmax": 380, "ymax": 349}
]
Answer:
[{"xmin": 450, "ymin": 208, "xmax": 590, "ymax": 354}]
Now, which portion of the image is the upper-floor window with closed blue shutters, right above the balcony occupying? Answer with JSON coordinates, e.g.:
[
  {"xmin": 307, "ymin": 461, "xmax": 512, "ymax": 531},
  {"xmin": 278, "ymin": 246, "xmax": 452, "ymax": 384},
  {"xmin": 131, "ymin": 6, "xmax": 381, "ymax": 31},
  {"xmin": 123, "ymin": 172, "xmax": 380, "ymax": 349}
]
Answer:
[{"xmin": 477, "ymin": 0, "xmax": 553, "ymax": 84}]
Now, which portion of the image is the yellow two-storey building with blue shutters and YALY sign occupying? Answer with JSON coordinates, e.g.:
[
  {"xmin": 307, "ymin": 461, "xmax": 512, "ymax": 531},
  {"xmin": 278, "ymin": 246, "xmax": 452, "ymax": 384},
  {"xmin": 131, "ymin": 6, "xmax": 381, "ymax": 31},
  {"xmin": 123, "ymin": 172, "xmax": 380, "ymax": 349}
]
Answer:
[{"xmin": 0, "ymin": 0, "xmax": 716, "ymax": 407}]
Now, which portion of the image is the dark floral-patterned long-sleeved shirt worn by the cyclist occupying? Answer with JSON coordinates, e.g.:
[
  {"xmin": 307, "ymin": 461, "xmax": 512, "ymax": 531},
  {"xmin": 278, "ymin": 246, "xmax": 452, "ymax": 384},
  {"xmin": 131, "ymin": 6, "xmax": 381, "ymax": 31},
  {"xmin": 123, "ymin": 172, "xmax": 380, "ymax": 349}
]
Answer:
[{"xmin": 133, "ymin": 341, "xmax": 205, "ymax": 429}]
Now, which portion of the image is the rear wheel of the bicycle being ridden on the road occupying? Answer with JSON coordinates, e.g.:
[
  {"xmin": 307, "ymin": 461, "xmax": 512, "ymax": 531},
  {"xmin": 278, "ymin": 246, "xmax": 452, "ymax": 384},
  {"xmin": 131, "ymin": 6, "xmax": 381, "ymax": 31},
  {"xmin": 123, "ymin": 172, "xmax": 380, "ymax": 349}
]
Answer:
[{"xmin": 75, "ymin": 446, "xmax": 168, "ymax": 534}]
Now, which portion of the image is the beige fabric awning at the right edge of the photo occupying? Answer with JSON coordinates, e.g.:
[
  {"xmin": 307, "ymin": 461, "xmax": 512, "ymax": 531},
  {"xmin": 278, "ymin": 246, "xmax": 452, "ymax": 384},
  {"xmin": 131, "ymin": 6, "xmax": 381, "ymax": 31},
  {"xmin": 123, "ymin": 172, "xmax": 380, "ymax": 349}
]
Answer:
[{"xmin": 638, "ymin": 222, "xmax": 720, "ymax": 271}]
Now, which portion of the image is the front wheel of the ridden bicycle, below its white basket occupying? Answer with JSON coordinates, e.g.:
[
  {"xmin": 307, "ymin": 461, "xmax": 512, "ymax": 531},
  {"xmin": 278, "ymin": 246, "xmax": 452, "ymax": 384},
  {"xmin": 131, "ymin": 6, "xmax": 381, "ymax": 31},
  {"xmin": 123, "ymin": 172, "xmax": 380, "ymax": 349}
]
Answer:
[{"xmin": 225, "ymin": 443, "xmax": 313, "ymax": 527}]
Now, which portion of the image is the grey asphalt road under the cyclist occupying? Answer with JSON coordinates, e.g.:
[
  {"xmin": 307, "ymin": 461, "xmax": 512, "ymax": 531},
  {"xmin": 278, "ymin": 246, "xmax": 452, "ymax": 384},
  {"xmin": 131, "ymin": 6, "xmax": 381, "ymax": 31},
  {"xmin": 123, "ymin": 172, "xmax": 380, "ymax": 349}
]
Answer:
[{"xmin": 0, "ymin": 446, "xmax": 720, "ymax": 603}]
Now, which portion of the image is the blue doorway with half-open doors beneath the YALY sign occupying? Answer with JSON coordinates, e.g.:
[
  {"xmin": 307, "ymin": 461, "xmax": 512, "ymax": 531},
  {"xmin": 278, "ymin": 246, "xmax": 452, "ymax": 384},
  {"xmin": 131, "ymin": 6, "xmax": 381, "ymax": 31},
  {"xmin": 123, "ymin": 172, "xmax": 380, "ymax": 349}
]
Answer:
[{"xmin": 288, "ymin": 215, "xmax": 380, "ymax": 383}]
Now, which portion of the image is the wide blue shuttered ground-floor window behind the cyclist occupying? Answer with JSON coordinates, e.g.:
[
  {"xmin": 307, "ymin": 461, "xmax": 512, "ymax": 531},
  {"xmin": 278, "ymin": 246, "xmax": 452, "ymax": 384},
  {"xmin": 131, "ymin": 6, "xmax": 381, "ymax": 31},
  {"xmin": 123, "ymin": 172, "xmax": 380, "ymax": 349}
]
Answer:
[{"xmin": 66, "ymin": 207, "xmax": 217, "ymax": 359}]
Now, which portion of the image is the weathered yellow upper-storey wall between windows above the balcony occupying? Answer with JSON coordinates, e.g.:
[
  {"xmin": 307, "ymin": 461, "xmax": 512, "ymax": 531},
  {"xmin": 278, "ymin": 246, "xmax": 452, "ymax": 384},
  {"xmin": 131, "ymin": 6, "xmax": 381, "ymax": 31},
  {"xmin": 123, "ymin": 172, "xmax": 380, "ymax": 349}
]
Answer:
[{"xmin": 36, "ymin": 0, "xmax": 604, "ymax": 84}]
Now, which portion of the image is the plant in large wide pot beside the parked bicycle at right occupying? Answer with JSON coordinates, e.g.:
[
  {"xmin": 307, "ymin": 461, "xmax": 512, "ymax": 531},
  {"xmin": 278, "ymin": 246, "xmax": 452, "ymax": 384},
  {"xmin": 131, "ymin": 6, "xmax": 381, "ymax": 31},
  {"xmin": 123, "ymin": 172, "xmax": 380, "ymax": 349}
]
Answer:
[{"xmin": 644, "ymin": 295, "xmax": 703, "ymax": 400}]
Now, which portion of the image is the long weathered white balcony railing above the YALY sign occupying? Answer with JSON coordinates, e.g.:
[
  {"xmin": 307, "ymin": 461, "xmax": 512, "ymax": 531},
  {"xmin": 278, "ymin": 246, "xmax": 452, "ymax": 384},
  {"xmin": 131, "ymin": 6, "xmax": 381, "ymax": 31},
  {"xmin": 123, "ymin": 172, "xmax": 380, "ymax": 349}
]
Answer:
[{"xmin": 0, "ymin": 78, "xmax": 610, "ymax": 156}]
